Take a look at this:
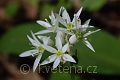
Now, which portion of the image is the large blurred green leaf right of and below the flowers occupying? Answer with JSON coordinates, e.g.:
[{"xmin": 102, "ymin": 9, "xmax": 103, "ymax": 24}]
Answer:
[{"xmin": 76, "ymin": 31, "xmax": 120, "ymax": 74}]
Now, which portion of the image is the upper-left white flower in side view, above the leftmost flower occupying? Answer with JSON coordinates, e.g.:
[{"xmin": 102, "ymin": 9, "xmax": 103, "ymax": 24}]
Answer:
[{"xmin": 35, "ymin": 12, "xmax": 72, "ymax": 35}]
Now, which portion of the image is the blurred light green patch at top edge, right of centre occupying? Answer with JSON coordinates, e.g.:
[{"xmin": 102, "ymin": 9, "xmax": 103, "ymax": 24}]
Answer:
[{"xmin": 81, "ymin": 0, "xmax": 107, "ymax": 11}]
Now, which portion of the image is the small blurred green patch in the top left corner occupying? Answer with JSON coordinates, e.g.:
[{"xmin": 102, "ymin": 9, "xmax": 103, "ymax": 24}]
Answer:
[{"xmin": 5, "ymin": 2, "xmax": 20, "ymax": 17}]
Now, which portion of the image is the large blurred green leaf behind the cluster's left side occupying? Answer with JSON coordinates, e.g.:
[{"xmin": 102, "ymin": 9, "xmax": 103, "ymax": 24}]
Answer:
[{"xmin": 0, "ymin": 23, "xmax": 42, "ymax": 54}]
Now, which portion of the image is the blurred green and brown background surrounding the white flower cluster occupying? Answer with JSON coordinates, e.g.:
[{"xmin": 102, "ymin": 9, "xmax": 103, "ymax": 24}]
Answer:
[{"xmin": 0, "ymin": 0, "xmax": 120, "ymax": 80}]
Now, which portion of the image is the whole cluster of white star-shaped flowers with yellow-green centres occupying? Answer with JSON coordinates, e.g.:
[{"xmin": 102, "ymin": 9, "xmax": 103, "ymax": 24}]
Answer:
[{"xmin": 20, "ymin": 7, "xmax": 100, "ymax": 71}]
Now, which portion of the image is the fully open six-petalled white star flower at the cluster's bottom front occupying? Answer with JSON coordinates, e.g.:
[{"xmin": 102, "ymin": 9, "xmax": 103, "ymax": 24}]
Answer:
[{"xmin": 41, "ymin": 32, "xmax": 76, "ymax": 69}]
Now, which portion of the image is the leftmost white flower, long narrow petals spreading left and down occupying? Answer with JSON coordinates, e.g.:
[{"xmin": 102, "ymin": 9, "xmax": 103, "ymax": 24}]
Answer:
[{"xmin": 19, "ymin": 32, "xmax": 50, "ymax": 71}]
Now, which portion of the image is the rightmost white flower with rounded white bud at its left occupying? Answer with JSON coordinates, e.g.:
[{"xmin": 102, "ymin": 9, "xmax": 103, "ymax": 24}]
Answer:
[{"xmin": 69, "ymin": 19, "xmax": 100, "ymax": 52}]
